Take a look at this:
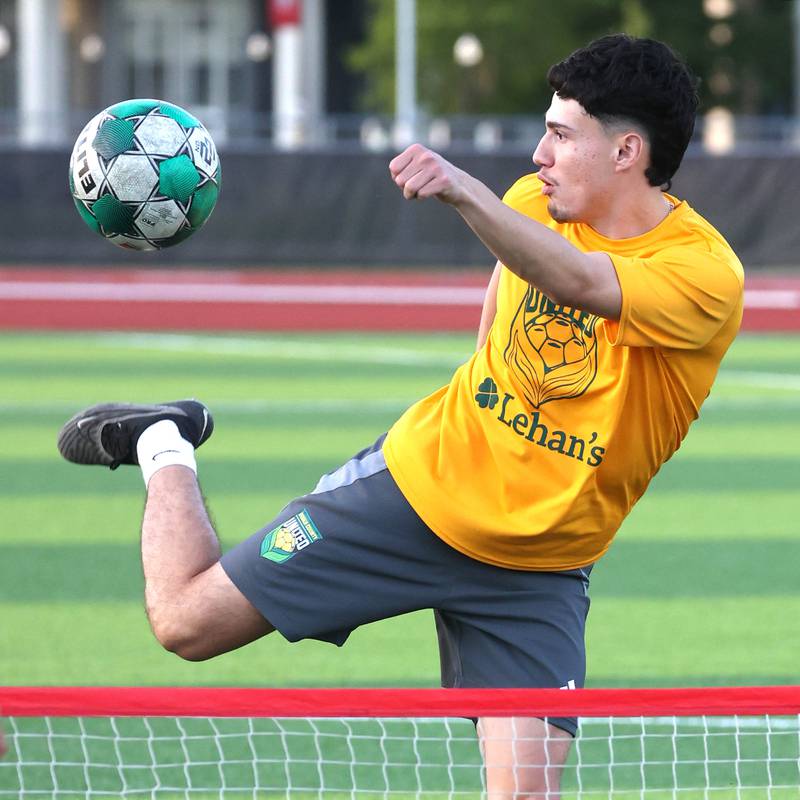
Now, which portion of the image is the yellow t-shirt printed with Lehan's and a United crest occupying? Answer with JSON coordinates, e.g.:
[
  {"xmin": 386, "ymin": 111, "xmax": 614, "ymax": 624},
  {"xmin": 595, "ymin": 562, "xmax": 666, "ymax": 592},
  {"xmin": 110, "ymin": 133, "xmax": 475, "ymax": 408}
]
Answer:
[{"xmin": 383, "ymin": 175, "xmax": 744, "ymax": 570}]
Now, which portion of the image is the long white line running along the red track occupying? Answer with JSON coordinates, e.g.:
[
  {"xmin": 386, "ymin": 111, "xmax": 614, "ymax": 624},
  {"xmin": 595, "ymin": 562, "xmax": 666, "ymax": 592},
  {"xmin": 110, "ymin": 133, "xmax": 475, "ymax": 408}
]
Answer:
[{"xmin": 0, "ymin": 281, "xmax": 800, "ymax": 310}]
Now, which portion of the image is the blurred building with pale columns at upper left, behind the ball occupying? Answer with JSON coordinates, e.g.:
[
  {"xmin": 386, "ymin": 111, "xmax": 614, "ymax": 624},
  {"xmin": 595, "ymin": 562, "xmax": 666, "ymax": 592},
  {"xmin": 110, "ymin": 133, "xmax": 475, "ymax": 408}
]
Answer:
[{"xmin": 0, "ymin": 0, "xmax": 364, "ymax": 147}]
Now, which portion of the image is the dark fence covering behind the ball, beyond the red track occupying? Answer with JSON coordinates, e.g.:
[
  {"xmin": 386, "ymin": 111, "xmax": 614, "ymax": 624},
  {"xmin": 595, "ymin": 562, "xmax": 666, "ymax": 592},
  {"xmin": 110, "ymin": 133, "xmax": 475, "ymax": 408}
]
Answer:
[{"xmin": 0, "ymin": 150, "xmax": 800, "ymax": 268}]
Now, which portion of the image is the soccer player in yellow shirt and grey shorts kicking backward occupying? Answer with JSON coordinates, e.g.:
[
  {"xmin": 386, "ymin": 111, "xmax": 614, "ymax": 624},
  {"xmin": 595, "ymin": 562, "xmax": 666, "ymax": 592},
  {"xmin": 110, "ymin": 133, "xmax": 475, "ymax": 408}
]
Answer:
[{"xmin": 60, "ymin": 35, "xmax": 743, "ymax": 800}]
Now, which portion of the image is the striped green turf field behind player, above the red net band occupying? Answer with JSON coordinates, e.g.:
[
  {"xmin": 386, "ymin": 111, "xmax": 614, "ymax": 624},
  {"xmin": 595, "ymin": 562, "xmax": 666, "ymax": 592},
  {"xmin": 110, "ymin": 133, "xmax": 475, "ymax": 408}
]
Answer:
[{"xmin": 0, "ymin": 334, "xmax": 800, "ymax": 797}]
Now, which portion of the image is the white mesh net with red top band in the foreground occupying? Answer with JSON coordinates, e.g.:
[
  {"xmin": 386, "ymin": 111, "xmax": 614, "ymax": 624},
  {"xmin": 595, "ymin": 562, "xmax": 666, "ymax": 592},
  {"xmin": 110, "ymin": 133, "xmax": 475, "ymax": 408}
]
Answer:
[{"xmin": 0, "ymin": 687, "xmax": 800, "ymax": 800}]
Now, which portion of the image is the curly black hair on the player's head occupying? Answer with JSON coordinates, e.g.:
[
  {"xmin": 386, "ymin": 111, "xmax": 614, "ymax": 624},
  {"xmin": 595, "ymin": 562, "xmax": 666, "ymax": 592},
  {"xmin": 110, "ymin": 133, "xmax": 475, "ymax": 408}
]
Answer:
[{"xmin": 547, "ymin": 33, "xmax": 698, "ymax": 189}]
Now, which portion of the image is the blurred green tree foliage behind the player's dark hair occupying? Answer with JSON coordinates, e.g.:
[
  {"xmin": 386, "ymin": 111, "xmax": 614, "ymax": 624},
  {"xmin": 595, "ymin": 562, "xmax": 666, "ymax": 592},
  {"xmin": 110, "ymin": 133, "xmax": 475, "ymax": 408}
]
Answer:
[{"xmin": 348, "ymin": 0, "xmax": 792, "ymax": 114}]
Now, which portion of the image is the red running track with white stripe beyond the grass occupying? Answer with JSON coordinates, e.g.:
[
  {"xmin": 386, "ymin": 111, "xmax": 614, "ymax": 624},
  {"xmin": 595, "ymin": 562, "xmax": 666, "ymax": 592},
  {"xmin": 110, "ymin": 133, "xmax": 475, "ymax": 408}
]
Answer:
[{"xmin": 0, "ymin": 268, "xmax": 800, "ymax": 331}]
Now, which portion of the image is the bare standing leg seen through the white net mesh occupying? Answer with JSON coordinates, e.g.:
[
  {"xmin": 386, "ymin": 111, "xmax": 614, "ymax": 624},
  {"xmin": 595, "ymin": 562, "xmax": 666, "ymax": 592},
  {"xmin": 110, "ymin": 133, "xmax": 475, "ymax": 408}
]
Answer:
[{"xmin": 478, "ymin": 717, "xmax": 572, "ymax": 800}]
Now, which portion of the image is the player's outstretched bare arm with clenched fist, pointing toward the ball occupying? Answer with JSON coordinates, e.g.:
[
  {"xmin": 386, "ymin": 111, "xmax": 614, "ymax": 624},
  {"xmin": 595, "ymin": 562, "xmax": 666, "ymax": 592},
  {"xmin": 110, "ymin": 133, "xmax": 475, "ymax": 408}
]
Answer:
[{"xmin": 389, "ymin": 144, "xmax": 622, "ymax": 320}]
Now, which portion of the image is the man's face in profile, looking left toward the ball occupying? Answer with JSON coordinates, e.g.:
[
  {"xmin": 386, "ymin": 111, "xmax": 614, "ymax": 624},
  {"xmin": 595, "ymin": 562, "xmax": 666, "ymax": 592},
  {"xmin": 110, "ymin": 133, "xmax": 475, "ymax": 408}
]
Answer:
[{"xmin": 533, "ymin": 95, "xmax": 617, "ymax": 223}]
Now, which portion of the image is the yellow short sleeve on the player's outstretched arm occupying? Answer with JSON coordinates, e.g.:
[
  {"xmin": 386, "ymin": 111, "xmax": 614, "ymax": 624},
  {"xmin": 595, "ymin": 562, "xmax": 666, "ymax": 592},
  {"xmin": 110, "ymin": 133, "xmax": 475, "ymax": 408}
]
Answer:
[{"xmin": 605, "ymin": 247, "xmax": 743, "ymax": 349}]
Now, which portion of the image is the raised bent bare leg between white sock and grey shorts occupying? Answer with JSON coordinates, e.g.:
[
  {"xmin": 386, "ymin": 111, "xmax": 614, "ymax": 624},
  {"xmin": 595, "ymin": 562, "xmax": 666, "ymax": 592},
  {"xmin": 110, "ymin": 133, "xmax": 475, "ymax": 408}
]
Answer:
[{"xmin": 142, "ymin": 466, "xmax": 274, "ymax": 661}]
